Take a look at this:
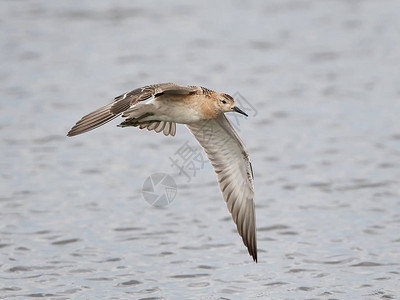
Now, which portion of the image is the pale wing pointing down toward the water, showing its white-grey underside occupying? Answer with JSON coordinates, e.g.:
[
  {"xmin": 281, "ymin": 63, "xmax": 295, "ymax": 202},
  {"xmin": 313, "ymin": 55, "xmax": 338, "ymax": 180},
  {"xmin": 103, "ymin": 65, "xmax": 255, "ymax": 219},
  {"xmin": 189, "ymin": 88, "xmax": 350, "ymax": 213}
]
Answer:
[{"xmin": 186, "ymin": 114, "xmax": 257, "ymax": 262}]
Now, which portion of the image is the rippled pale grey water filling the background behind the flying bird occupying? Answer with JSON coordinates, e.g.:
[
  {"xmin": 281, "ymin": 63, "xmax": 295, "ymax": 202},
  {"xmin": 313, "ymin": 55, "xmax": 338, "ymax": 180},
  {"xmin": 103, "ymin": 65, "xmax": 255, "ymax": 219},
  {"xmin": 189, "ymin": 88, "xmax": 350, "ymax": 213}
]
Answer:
[{"xmin": 0, "ymin": 0, "xmax": 400, "ymax": 299}]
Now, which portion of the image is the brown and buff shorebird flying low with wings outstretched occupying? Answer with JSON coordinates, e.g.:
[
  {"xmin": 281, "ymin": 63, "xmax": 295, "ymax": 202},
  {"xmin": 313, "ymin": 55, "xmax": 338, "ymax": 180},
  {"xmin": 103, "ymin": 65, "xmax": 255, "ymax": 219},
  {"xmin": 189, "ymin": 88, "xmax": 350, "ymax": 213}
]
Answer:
[{"xmin": 67, "ymin": 83, "xmax": 257, "ymax": 262}]
